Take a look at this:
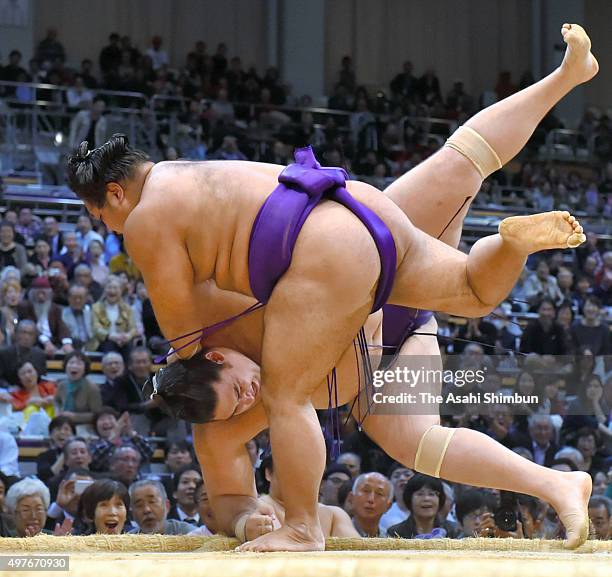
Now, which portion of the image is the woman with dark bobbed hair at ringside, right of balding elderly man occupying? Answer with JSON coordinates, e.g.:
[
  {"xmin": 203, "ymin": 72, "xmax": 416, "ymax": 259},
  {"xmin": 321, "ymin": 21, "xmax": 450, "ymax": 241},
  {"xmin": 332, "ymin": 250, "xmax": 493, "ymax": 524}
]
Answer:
[{"xmin": 387, "ymin": 473, "xmax": 456, "ymax": 539}]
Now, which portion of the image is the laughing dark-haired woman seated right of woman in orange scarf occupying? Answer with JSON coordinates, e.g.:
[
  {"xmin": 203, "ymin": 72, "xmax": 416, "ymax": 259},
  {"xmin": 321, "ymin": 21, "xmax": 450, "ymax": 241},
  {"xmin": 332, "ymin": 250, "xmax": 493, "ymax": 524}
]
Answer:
[{"xmin": 55, "ymin": 351, "xmax": 102, "ymax": 424}]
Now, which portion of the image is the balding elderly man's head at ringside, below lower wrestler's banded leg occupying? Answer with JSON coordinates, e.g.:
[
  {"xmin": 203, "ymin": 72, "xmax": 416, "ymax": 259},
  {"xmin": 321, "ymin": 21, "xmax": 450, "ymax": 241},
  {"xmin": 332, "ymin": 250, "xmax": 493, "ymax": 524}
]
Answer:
[{"xmin": 348, "ymin": 473, "xmax": 393, "ymax": 537}]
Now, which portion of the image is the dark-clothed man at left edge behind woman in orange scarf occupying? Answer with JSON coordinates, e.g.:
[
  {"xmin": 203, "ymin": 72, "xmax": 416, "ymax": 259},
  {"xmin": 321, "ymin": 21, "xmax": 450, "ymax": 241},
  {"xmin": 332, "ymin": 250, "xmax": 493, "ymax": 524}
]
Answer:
[{"xmin": 0, "ymin": 319, "xmax": 47, "ymax": 388}]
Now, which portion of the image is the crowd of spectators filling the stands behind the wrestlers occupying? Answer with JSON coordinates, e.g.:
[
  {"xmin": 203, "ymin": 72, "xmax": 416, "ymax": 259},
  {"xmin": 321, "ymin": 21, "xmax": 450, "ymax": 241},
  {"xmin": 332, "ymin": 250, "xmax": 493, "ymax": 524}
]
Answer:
[{"xmin": 0, "ymin": 30, "xmax": 612, "ymax": 539}]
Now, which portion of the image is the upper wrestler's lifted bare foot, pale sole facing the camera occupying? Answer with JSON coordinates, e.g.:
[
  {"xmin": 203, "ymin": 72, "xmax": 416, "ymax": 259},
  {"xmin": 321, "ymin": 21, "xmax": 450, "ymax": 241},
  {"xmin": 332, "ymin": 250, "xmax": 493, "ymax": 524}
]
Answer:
[{"xmin": 499, "ymin": 210, "xmax": 586, "ymax": 254}]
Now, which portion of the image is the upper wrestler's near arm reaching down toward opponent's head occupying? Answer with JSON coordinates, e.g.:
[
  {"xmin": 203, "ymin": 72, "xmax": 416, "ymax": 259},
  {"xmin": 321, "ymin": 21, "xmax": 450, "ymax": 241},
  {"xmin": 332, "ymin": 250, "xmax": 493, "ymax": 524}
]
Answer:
[{"xmin": 124, "ymin": 214, "xmax": 202, "ymax": 358}]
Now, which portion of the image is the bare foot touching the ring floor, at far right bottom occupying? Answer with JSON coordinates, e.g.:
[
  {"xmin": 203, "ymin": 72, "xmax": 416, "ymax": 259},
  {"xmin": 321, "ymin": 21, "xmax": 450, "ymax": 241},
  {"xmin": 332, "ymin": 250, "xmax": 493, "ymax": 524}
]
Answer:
[{"xmin": 551, "ymin": 471, "xmax": 593, "ymax": 549}]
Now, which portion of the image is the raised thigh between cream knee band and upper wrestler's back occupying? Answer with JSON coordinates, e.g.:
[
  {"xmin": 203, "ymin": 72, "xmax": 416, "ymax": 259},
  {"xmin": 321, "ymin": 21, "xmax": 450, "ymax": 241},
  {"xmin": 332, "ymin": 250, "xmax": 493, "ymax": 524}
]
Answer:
[{"xmin": 384, "ymin": 146, "xmax": 482, "ymax": 238}]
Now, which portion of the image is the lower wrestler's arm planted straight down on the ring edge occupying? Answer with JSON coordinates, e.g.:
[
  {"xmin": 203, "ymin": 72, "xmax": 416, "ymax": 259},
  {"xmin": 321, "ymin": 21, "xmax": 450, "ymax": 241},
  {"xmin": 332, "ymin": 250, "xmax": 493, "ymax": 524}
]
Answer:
[{"xmin": 193, "ymin": 403, "xmax": 268, "ymax": 535}]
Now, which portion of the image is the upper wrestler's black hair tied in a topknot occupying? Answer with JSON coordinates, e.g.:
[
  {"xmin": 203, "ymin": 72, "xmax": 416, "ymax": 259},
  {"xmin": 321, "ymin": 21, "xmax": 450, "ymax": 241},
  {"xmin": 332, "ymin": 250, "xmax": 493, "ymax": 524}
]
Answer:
[{"xmin": 66, "ymin": 134, "xmax": 148, "ymax": 208}]
